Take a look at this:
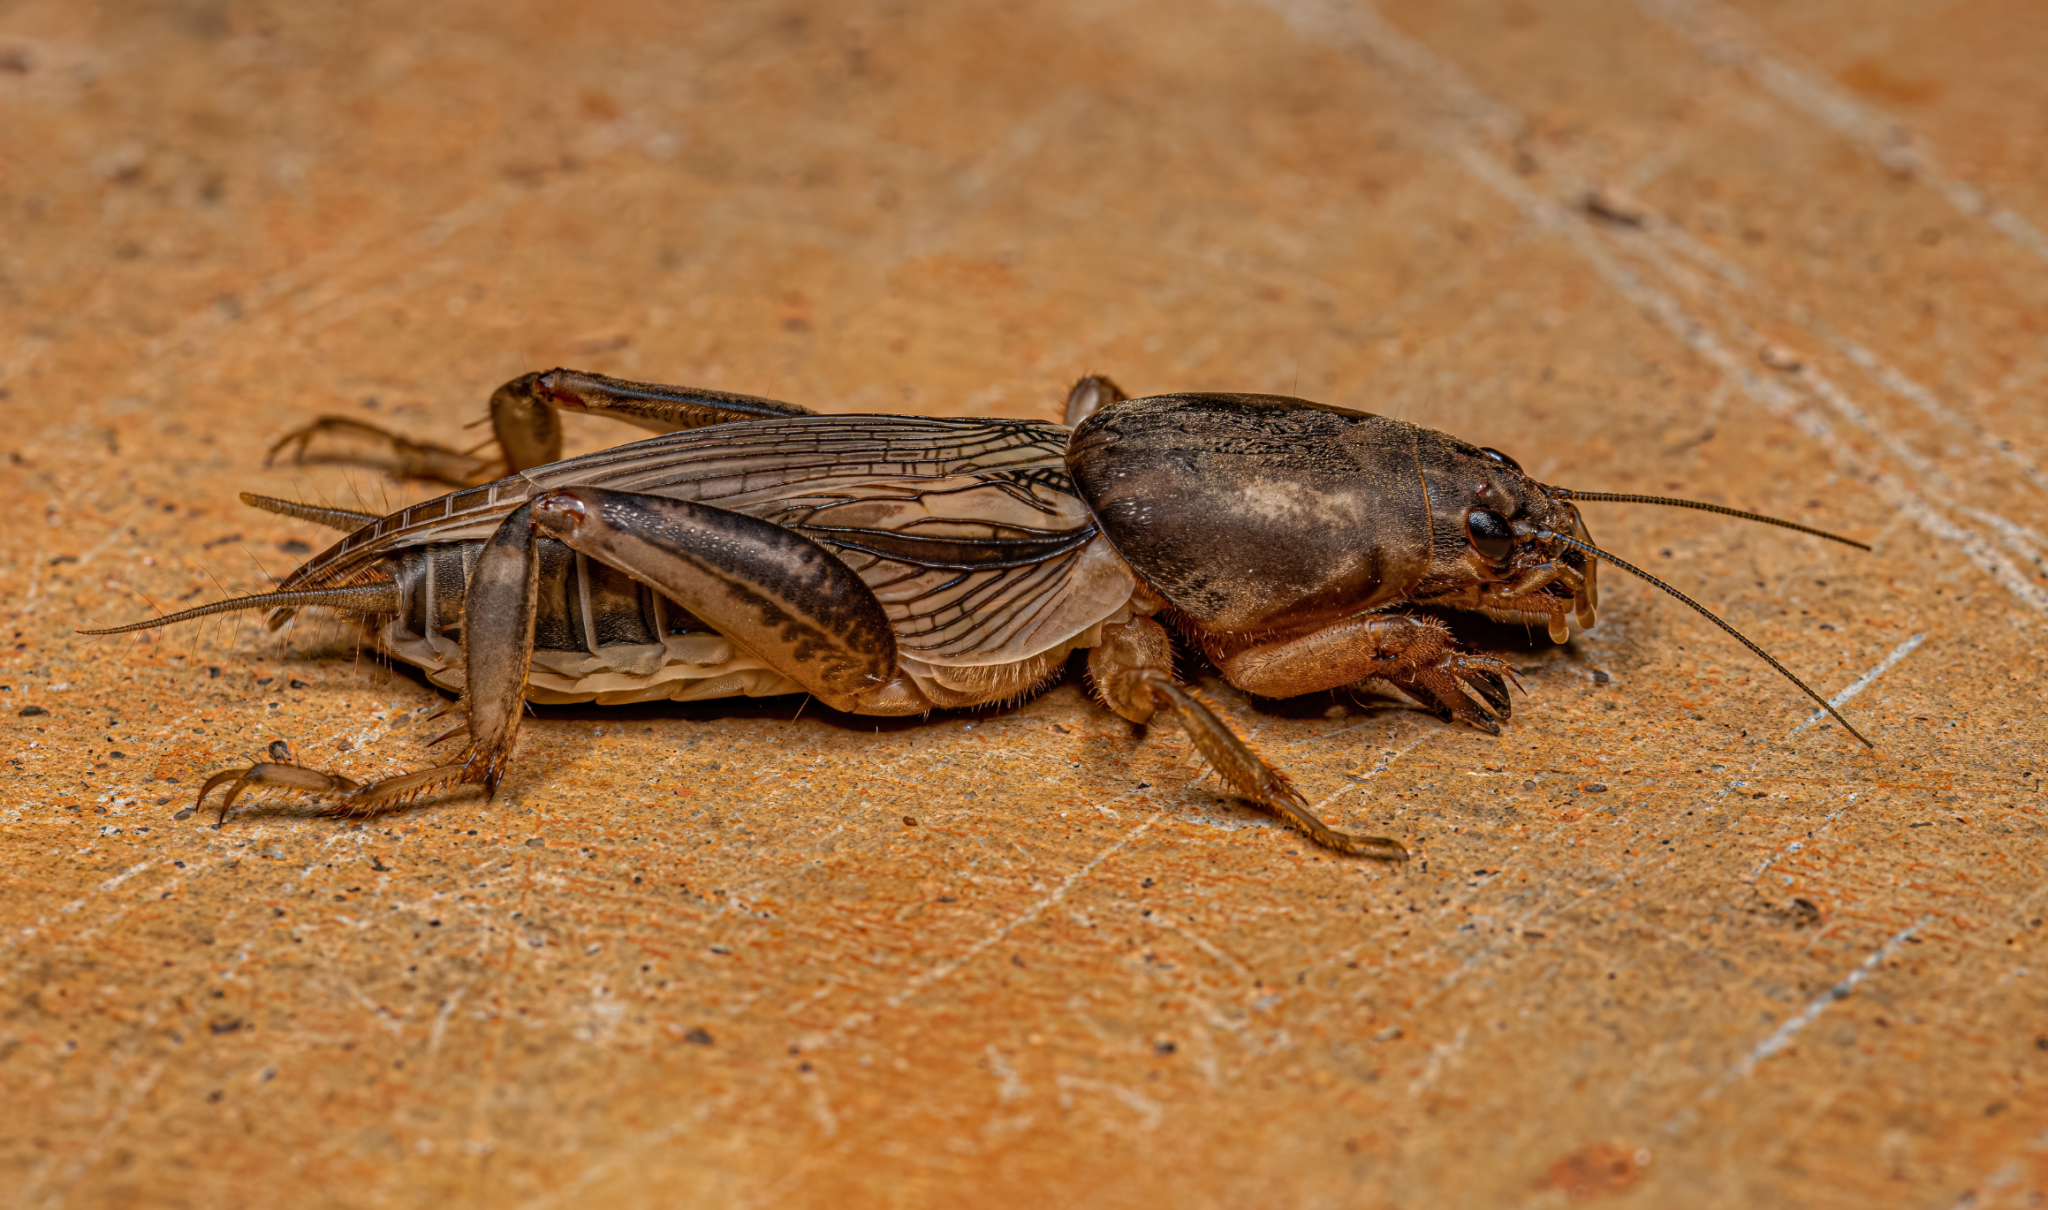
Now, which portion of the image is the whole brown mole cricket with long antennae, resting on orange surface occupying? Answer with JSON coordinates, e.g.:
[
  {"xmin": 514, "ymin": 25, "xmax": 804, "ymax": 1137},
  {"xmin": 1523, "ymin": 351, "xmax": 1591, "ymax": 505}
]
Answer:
[{"xmin": 88, "ymin": 371, "xmax": 1868, "ymax": 858}]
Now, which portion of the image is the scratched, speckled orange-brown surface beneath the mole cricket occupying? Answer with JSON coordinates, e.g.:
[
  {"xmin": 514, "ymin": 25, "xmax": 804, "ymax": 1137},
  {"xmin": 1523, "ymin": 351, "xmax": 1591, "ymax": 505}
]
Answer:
[{"xmin": 0, "ymin": 0, "xmax": 2048, "ymax": 1208}]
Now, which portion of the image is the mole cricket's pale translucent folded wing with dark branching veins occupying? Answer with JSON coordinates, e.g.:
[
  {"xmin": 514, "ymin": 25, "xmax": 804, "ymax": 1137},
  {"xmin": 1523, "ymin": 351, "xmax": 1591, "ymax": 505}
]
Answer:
[{"xmin": 281, "ymin": 416, "xmax": 1133, "ymax": 665}]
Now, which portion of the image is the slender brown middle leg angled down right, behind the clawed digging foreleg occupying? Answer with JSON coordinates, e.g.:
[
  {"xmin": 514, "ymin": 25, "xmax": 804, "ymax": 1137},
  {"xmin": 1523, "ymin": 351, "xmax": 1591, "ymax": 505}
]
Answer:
[{"xmin": 1087, "ymin": 618, "xmax": 1407, "ymax": 860}]
